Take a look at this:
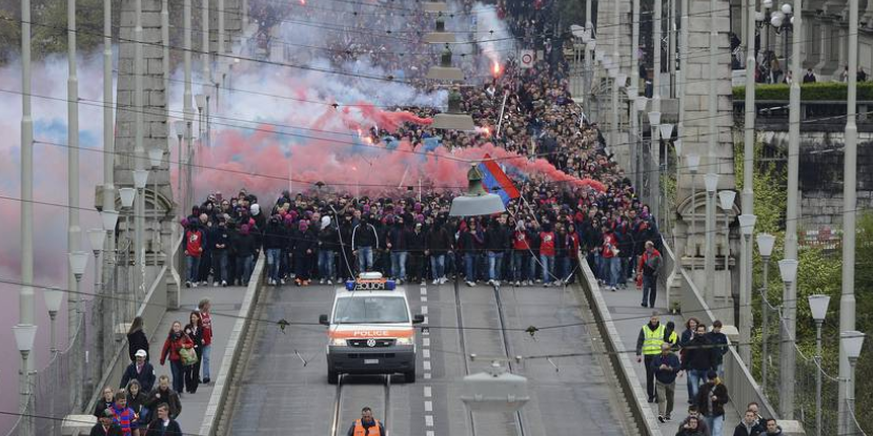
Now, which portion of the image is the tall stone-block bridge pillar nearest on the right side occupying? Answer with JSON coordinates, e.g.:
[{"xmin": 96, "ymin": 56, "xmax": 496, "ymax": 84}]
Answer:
[{"xmin": 676, "ymin": 0, "xmax": 736, "ymax": 312}]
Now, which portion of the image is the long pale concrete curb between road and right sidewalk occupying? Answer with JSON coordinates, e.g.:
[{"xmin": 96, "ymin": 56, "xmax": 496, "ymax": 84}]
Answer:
[{"xmin": 579, "ymin": 256, "xmax": 662, "ymax": 436}]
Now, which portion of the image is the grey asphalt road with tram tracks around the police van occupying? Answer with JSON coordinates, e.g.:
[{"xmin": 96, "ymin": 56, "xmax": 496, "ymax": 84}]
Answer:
[{"xmin": 230, "ymin": 283, "xmax": 624, "ymax": 436}]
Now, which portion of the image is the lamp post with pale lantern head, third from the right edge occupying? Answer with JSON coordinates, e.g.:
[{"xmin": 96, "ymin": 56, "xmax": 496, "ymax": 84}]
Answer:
[{"xmin": 779, "ymin": 259, "xmax": 799, "ymax": 419}]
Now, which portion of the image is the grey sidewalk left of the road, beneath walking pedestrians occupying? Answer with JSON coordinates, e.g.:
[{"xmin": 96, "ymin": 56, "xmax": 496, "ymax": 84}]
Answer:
[{"xmin": 150, "ymin": 286, "xmax": 246, "ymax": 433}]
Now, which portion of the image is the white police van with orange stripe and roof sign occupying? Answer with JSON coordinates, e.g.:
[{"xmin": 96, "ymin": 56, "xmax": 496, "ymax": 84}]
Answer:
[{"xmin": 319, "ymin": 272, "xmax": 424, "ymax": 384}]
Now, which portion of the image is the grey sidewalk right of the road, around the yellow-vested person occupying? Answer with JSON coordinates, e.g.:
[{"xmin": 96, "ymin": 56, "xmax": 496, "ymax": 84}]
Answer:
[{"xmin": 601, "ymin": 286, "xmax": 736, "ymax": 435}]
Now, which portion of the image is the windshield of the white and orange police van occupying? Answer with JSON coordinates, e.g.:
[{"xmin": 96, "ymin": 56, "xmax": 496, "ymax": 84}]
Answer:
[{"xmin": 333, "ymin": 297, "xmax": 409, "ymax": 324}]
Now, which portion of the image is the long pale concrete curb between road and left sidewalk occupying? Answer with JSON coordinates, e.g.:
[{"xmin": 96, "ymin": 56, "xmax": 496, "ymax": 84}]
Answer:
[{"xmin": 198, "ymin": 253, "xmax": 266, "ymax": 436}]
